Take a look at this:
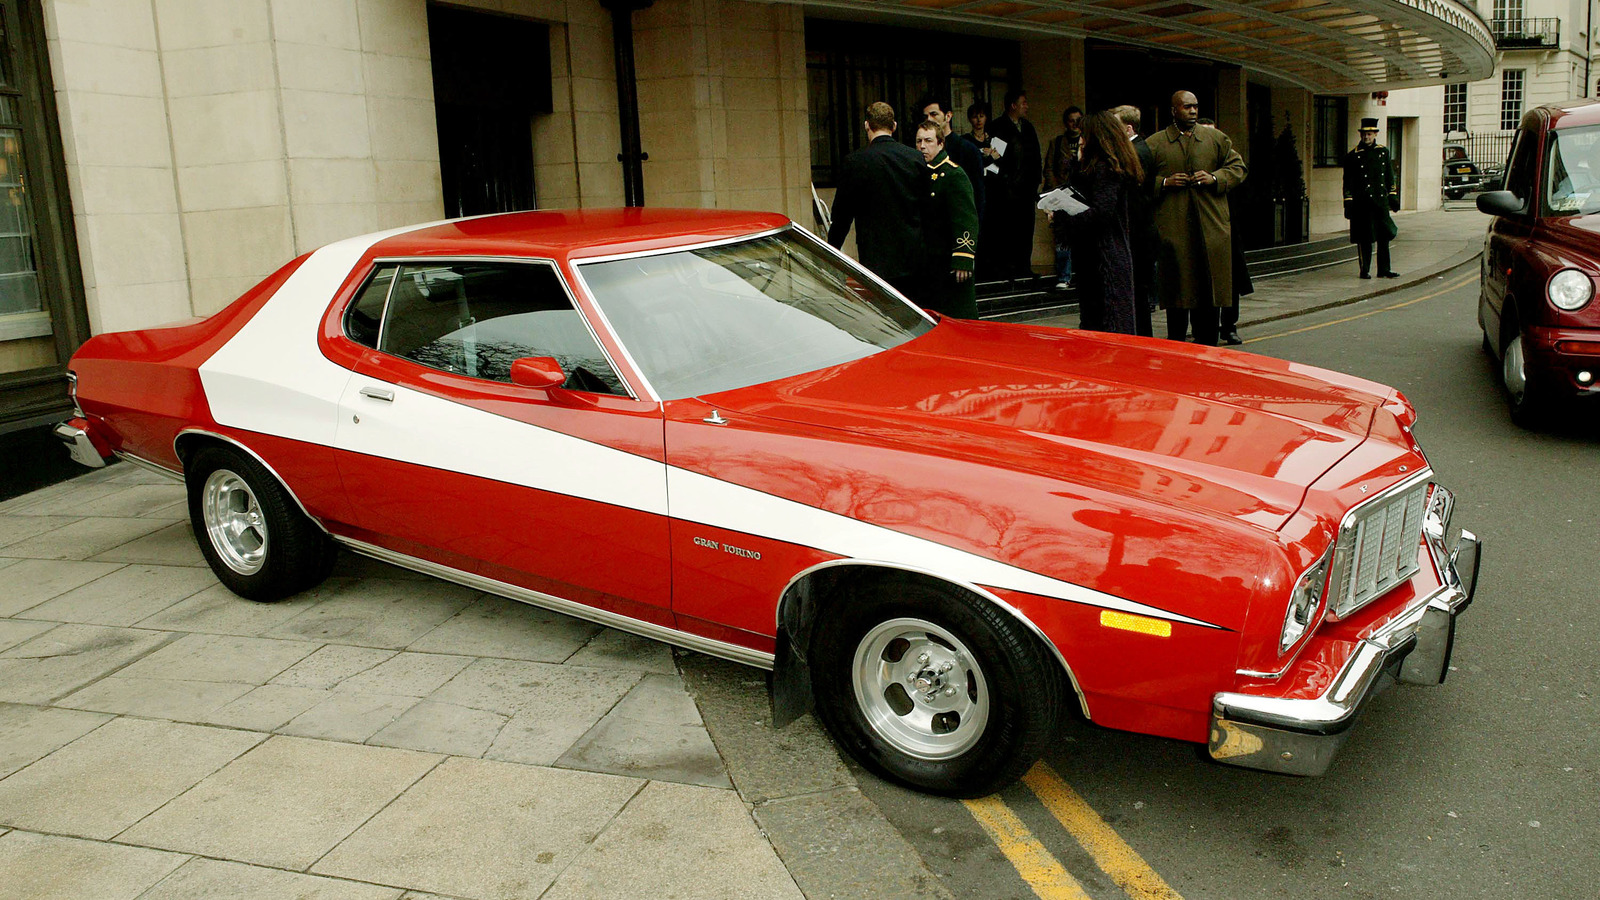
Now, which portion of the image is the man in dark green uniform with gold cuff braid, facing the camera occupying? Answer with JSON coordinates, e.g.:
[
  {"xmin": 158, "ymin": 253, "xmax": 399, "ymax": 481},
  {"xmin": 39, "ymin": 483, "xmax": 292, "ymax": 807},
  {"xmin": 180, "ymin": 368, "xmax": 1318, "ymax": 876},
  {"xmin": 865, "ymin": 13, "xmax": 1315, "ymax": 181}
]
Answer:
[{"xmin": 917, "ymin": 122, "xmax": 978, "ymax": 319}]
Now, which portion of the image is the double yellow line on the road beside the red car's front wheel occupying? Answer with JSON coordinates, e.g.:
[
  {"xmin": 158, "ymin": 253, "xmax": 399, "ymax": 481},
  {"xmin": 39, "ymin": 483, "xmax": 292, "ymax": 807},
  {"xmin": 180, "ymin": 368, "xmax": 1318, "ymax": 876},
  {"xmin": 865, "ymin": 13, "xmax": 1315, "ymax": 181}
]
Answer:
[{"xmin": 962, "ymin": 762, "xmax": 1182, "ymax": 900}]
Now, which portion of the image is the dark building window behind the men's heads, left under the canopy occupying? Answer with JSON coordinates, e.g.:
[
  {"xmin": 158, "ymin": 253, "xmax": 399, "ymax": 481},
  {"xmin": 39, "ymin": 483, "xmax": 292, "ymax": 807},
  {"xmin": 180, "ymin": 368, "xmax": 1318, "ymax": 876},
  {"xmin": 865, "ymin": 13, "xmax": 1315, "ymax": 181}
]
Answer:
[{"xmin": 805, "ymin": 19, "xmax": 1017, "ymax": 187}]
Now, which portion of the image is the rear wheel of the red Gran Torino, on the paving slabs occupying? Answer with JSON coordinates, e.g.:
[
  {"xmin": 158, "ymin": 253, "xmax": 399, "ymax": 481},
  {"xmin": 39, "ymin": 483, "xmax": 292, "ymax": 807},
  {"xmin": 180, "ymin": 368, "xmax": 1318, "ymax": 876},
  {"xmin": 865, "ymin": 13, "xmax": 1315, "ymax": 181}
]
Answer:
[{"xmin": 184, "ymin": 445, "xmax": 338, "ymax": 602}]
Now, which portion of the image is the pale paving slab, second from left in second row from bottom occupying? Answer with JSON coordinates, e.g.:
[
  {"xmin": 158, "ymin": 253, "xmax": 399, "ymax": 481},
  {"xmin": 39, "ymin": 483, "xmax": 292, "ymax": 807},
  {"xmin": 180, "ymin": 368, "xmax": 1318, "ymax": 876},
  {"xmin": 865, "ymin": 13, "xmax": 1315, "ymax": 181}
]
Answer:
[{"xmin": 118, "ymin": 737, "xmax": 442, "ymax": 871}]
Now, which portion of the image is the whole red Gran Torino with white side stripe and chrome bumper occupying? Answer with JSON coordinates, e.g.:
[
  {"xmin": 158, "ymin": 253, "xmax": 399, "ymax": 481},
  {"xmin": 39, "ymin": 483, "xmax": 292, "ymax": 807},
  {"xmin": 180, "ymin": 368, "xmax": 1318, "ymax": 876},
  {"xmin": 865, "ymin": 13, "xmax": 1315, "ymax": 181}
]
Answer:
[{"xmin": 56, "ymin": 210, "xmax": 1478, "ymax": 796}]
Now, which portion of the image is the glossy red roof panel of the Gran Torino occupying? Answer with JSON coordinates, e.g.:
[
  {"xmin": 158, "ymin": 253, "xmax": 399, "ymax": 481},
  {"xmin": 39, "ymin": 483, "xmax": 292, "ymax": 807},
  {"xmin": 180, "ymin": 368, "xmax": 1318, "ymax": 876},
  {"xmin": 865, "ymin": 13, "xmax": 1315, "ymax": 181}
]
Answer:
[{"xmin": 373, "ymin": 208, "xmax": 789, "ymax": 261}]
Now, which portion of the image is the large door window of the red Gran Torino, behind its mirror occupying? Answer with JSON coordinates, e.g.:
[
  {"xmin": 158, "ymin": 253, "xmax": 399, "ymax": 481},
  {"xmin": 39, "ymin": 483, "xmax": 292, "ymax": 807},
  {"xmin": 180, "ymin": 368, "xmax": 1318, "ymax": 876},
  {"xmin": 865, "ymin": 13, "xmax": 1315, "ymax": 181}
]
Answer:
[{"xmin": 378, "ymin": 263, "xmax": 627, "ymax": 396}]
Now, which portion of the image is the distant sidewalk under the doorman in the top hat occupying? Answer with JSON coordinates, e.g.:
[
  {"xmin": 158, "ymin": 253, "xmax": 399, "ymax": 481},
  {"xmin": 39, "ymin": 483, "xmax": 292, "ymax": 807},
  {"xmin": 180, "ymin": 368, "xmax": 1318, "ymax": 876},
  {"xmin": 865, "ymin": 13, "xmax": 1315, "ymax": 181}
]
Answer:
[{"xmin": 1027, "ymin": 205, "xmax": 1490, "ymax": 333}]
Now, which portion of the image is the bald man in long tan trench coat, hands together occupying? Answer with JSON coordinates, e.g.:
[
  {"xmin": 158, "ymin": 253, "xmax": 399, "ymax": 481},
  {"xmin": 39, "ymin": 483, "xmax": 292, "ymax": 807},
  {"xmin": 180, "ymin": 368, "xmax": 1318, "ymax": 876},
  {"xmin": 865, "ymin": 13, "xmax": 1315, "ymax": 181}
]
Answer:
[{"xmin": 1146, "ymin": 91, "xmax": 1246, "ymax": 346}]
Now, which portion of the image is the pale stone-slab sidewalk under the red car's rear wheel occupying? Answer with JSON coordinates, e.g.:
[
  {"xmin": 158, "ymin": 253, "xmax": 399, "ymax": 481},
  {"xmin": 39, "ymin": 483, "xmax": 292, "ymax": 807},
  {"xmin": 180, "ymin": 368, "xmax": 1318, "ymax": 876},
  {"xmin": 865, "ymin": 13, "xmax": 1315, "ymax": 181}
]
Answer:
[{"xmin": 0, "ymin": 464, "xmax": 800, "ymax": 900}]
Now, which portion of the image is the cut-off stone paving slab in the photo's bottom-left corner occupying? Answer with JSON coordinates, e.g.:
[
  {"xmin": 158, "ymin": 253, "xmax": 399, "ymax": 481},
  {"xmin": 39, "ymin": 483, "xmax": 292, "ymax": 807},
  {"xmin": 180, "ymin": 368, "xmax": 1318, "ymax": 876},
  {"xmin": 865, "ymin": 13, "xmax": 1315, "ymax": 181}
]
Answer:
[{"xmin": 0, "ymin": 831, "xmax": 187, "ymax": 900}]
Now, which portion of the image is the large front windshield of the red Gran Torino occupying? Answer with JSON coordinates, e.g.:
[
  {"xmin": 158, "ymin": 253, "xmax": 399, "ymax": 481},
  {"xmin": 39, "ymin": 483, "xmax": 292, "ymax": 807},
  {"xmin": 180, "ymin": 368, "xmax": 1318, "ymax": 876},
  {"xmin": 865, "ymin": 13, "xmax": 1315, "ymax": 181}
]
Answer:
[{"xmin": 579, "ymin": 229, "xmax": 933, "ymax": 400}]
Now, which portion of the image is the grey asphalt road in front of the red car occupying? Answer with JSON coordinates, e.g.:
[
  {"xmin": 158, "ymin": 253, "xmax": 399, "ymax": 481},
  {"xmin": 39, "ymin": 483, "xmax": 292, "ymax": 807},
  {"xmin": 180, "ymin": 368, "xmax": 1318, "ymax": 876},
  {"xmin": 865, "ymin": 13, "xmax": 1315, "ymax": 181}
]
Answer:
[{"xmin": 861, "ymin": 264, "xmax": 1600, "ymax": 900}]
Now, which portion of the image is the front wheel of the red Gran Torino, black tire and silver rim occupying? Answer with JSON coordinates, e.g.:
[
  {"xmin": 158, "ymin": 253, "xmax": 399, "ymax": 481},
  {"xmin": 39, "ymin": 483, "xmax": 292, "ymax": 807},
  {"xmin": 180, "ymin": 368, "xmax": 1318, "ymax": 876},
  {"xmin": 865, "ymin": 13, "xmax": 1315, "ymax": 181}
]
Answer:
[{"xmin": 810, "ymin": 575, "xmax": 1067, "ymax": 798}]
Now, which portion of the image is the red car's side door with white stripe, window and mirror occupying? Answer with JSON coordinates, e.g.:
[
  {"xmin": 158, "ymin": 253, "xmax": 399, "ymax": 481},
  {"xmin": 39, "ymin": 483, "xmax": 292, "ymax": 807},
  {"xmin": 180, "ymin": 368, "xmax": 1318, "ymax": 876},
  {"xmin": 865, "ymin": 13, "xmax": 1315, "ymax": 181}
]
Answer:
[{"xmin": 336, "ymin": 261, "xmax": 672, "ymax": 625}]
